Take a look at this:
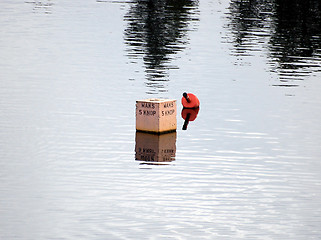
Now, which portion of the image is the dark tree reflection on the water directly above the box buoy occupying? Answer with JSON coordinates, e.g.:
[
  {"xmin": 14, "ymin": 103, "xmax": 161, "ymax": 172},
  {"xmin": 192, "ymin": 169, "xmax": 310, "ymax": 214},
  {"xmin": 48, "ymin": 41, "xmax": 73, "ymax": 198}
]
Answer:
[{"xmin": 124, "ymin": 0, "xmax": 198, "ymax": 94}]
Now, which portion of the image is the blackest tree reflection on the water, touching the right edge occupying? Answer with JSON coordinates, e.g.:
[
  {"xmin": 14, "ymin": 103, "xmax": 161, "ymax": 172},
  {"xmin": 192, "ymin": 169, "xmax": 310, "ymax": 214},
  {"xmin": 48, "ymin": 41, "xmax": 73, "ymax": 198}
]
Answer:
[{"xmin": 270, "ymin": 0, "xmax": 321, "ymax": 81}]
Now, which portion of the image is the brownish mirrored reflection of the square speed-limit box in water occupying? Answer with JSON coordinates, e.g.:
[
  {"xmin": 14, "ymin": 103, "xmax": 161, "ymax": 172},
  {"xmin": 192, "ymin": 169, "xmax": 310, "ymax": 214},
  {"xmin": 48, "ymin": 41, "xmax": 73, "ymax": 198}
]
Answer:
[{"xmin": 135, "ymin": 132, "xmax": 176, "ymax": 162}]
